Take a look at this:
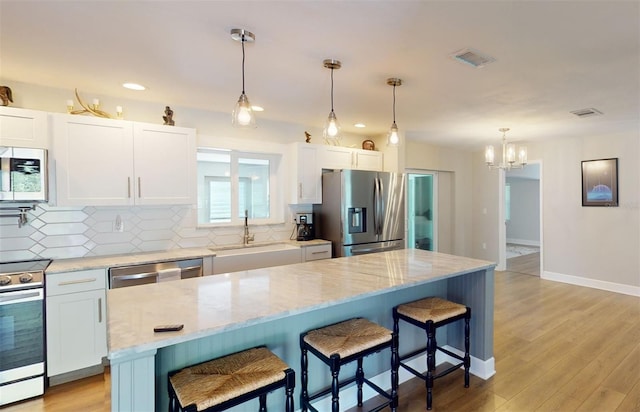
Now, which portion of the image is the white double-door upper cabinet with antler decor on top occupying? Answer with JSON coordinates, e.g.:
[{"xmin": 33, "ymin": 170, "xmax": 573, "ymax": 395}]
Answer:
[{"xmin": 52, "ymin": 114, "xmax": 196, "ymax": 206}]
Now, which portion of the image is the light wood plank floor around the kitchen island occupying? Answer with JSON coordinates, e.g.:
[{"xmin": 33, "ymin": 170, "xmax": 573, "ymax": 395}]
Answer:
[{"xmin": 3, "ymin": 271, "xmax": 640, "ymax": 412}]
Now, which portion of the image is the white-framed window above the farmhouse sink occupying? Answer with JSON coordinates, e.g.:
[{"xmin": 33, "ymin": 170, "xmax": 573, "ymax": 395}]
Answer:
[{"xmin": 198, "ymin": 148, "xmax": 279, "ymax": 225}]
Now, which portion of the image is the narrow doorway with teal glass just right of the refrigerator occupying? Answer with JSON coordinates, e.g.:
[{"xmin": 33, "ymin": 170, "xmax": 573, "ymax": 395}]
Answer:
[{"xmin": 406, "ymin": 171, "xmax": 438, "ymax": 251}]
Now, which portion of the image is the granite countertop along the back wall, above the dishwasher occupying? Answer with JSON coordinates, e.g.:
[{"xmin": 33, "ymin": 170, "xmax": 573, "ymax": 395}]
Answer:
[{"xmin": 46, "ymin": 239, "xmax": 331, "ymax": 274}]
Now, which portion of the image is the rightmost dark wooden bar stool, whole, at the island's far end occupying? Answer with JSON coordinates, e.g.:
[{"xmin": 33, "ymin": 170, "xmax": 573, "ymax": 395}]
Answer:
[{"xmin": 393, "ymin": 297, "xmax": 471, "ymax": 409}]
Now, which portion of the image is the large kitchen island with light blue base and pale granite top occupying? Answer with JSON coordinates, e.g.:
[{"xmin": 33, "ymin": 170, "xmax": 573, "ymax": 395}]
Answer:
[{"xmin": 107, "ymin": 249, "xmax": 495, "ymax": 411}]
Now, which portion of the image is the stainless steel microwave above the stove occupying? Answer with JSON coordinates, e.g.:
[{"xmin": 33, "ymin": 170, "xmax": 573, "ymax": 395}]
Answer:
[{"xmin": 0, "ymin": 146, "xmax": 48, "ymax": 202}]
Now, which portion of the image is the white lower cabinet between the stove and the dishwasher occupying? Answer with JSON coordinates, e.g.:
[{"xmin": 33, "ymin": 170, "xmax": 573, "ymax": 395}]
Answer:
[{"xmin": 46, "ymin": 269, "xmax": 107, "ymax": 377}]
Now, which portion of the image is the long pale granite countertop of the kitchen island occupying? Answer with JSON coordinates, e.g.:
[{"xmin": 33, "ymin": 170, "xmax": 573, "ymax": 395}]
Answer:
[{"xmin": 107, "ymin": 249, "xmax": 495, "ymax": 359}]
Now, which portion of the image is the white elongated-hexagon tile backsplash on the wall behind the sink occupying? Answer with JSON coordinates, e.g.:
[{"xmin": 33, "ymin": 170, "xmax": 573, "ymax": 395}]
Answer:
[{"xmin": 0, "ymin": 204, "xmax": 292, "ymax": 262}]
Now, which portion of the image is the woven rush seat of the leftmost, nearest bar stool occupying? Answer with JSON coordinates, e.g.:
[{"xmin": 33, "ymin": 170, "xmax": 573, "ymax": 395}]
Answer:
[{"xmin": 169, "ymin": 347, "xmax": 293, "ymax": 411}]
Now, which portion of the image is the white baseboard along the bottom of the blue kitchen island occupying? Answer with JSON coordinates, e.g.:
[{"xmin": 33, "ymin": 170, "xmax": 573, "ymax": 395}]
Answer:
[{"xmin": 306, "ymin": 345, "xmax": 496, "ymax": 411}]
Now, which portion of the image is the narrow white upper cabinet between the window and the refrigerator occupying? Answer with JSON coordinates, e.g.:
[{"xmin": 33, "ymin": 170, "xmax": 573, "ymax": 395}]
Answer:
[{"xmin": 289, "ymin": 143, "xmax": 322, "ymax": 204}]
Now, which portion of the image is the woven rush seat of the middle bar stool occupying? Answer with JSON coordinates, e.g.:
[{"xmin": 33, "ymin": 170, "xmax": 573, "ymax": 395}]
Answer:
[{"xmin": 304, "ymin": 318, "xmax": 392, "ymax": 358}]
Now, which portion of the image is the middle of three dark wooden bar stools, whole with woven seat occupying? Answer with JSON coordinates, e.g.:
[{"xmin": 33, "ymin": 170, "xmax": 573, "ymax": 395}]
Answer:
[{"xmin": 300, "ymin": 318, "xmax": 398, "ymax": 412}]
